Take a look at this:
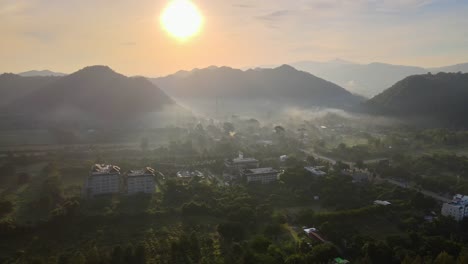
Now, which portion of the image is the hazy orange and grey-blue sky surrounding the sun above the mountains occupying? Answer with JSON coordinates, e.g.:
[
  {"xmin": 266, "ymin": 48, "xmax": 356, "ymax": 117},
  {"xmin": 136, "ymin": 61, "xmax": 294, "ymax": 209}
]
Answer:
[{"xmin": 0, "ymin": 0, "xmax": 468, "ymax": 76}]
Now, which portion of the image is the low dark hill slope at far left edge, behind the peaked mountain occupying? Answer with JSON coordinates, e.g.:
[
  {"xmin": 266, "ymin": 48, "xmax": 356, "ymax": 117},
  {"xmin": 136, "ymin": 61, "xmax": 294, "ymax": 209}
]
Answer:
[{"xmin": 0, "ymin": 73, "xmax": 60, "ymax": 106}]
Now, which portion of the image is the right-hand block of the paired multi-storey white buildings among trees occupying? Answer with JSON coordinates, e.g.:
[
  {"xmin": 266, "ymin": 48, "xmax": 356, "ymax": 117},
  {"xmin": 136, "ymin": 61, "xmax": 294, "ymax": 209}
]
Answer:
[{"xmin": 127, "ymin": 167, "xmax": 156, "ymax": 195}]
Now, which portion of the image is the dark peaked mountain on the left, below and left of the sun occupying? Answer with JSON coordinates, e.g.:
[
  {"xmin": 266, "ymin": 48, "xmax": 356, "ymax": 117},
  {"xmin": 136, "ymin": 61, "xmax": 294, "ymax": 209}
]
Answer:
[{"xmin": 7, "ymin": 66, "xmax": 175, "ymax": 125}]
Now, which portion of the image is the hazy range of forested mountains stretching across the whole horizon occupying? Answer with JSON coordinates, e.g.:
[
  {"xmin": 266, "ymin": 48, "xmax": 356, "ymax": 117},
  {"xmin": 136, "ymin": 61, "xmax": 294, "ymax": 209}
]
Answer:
[{"xmin": 0, "ymin": 61, "xmax": 468, "ymax": 127}]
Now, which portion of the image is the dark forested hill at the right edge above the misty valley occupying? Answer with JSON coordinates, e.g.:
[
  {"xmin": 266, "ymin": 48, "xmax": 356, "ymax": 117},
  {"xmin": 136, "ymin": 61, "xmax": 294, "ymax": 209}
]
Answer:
[{"xmin": 364, "ymin": 73, "xmax": 468, "ymax": 126}]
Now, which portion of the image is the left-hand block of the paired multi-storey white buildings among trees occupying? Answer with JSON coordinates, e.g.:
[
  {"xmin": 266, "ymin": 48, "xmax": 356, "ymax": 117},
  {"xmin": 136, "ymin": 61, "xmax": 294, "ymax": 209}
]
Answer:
[{"xmin": 83, "ymin": 164, "xmax": 122, "ymax": 197}]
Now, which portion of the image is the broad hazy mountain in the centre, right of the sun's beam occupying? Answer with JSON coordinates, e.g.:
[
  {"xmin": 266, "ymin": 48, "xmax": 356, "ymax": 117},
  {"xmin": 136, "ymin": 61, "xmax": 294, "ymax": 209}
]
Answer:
[{"xmin": 153, "ymin": 65, "xmax": 363, "ymax": 116}]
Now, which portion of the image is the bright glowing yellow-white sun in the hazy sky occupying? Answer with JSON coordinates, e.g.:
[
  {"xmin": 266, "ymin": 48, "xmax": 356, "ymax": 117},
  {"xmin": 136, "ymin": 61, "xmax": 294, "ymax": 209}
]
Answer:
[{"xmin": 161, "ymin": 0, "xmax": 203, "ymax": 40}]
